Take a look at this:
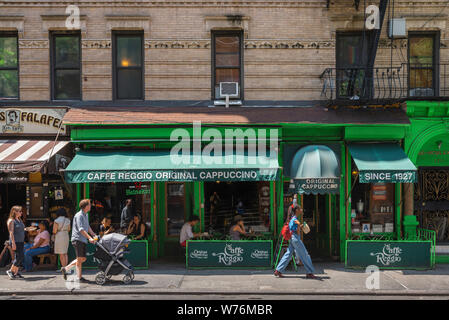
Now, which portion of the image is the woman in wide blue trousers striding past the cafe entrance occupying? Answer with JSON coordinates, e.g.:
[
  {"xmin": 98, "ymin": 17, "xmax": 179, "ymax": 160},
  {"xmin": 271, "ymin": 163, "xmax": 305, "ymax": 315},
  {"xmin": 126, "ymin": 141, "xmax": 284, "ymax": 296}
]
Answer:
[{"xmin": 274, "ymin": 205, "xmax": 316, "ymax": 279}]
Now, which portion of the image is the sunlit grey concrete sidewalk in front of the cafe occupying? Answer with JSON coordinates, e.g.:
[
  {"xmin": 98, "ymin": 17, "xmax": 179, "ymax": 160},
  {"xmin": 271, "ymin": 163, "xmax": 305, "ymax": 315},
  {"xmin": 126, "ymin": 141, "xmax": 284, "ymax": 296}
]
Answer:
[{"xmin": 0, "ymin": 263, "xmax": 449, "ymax": 296}]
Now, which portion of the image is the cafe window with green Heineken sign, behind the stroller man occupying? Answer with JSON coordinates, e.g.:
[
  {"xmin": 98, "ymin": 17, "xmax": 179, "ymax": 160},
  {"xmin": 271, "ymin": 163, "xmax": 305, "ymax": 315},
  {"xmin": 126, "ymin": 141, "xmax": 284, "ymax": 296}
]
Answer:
[{"xmin": 89, "ymin": 182, "xmax": 151, "ymax": 234}]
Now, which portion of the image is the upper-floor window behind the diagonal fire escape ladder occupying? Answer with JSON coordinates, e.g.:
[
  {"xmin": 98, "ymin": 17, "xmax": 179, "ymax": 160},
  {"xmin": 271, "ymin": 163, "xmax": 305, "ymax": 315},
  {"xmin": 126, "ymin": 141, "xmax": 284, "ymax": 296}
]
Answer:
[{"xmin": 336, "ymin": 32, "xmax": 372, "ymax": 99}]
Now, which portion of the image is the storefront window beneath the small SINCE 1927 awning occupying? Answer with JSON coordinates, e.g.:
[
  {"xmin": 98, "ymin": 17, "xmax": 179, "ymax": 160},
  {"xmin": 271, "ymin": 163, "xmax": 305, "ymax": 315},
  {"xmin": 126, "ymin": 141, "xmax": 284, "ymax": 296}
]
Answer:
[{"xmin": 350, "ymin": 169, "xmax": 395, "ymax": 233}]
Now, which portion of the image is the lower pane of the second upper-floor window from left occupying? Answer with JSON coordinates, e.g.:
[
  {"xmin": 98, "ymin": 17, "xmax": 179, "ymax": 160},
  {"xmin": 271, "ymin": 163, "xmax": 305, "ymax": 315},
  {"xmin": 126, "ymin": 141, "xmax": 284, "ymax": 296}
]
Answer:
[{"xmin": 55, "ymin": 70, "xmax": 80, "ymax": 100}]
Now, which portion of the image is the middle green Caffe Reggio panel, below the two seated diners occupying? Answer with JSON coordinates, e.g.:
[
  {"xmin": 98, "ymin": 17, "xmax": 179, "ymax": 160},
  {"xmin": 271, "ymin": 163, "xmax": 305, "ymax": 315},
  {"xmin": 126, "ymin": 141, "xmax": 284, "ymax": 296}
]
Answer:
[{"xmin": 186, "ymin": 240, "xmax": 273, "ymax": 269}]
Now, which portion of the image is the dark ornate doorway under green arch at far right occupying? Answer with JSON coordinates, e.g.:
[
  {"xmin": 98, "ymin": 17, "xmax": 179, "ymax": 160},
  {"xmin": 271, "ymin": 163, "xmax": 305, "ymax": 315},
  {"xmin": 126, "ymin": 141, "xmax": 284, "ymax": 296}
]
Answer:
[{"xmin": 414, "ymin": 167, "xmax": 449, "ymax": 243}]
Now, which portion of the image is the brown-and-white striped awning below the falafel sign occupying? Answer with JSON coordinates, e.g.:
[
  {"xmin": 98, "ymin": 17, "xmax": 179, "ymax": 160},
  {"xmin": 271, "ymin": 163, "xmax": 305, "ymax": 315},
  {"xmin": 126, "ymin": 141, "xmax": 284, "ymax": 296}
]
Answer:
[{"xmin": 0, "ymin": 140, "xmax": 69, "ymax": 173}]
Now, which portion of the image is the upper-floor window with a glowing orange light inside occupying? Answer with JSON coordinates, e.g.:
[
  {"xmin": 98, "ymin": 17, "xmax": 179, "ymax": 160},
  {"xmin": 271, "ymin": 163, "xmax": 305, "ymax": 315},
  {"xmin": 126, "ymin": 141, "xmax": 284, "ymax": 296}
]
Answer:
[{"xmin": 113, "ymin": 33, "xmax": 144, "ymax": 100}]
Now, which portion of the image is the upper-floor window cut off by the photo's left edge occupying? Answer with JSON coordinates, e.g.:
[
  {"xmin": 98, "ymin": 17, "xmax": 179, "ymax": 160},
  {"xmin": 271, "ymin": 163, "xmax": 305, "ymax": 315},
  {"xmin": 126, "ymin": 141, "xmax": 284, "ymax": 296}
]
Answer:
[{"xmin": 0, "ymin": 33, "xmax": 19, "ymax": 99}]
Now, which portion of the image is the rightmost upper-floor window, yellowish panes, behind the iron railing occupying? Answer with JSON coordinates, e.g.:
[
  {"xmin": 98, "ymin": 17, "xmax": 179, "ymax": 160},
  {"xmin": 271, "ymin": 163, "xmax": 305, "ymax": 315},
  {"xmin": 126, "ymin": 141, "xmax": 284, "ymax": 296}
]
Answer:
[{"xmin": 408, "ymin": 32, "xmax": 439, "ymax": 97}]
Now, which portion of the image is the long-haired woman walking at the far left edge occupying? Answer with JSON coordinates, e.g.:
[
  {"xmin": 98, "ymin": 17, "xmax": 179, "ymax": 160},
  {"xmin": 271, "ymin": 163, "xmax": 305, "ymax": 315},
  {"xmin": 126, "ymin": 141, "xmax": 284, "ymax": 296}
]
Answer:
[{"xmin": 6, "ymin": 206, "xmax": 25, "ymax": 280}]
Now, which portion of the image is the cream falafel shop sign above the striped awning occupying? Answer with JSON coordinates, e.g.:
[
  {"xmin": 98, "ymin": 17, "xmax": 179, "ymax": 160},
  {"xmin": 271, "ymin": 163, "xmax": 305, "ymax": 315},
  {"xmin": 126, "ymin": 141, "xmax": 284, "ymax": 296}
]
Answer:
[{"xmin": 0, "ymin": 107, "xmax": 67, "ymax": 135}]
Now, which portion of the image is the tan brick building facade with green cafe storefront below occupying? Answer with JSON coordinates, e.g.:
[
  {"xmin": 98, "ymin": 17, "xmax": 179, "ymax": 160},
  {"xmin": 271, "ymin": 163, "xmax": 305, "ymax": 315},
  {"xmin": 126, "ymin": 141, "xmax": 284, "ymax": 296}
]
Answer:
[{"xmin": 0, "ymin": 0, "xmax": 449, "ymax": 261}]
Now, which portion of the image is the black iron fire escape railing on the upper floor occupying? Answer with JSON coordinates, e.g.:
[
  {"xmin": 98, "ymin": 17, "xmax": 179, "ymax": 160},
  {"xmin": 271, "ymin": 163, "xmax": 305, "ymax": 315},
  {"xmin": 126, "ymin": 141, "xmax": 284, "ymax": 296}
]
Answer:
[{"xmin": 320, "ymin": 63, "xmax": 449, "ymax": 104}]
